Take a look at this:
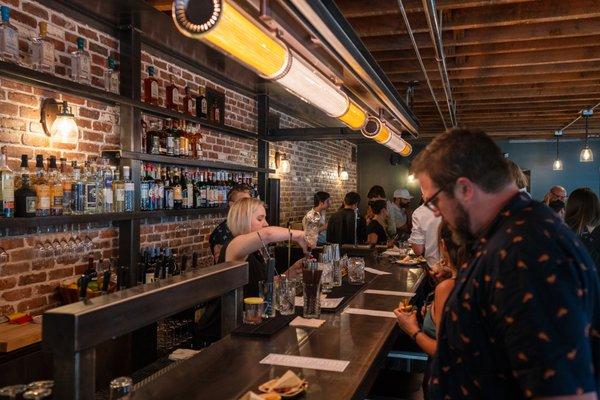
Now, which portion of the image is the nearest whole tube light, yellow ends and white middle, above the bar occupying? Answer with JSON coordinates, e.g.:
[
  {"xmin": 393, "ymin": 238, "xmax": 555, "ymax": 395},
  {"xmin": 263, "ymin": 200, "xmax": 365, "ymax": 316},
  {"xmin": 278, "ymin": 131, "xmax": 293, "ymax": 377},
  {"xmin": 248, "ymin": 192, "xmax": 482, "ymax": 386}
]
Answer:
[{"xmin": 172, "ymin": 0, "xmax": 367, "ymax": 130}]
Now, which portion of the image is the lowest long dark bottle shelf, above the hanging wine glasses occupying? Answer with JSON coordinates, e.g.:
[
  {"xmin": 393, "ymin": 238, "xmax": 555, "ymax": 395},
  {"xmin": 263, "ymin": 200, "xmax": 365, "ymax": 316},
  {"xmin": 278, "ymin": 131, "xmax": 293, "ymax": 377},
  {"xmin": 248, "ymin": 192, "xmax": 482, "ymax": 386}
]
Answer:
[{"xmin": 0, "ymin": 207, "xmax": 228, "ymax": 230}]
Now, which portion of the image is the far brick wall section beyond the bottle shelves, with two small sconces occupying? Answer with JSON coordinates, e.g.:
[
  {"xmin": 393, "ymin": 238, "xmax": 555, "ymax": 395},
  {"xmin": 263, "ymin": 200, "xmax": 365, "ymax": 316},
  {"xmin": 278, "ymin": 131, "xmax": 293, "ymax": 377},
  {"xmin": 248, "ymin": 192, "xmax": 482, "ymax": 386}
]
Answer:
[{"xmin": 269, "ymin": 110, "xmax": 357, "ymax": 226}]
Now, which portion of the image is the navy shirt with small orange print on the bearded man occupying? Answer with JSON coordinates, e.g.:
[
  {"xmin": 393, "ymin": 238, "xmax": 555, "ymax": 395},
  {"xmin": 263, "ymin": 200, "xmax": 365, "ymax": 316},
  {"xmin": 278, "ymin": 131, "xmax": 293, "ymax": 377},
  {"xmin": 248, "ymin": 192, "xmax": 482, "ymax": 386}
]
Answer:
[{"xmin": 429, "ymin": 194, "xmax": 600, "ymax": 399}]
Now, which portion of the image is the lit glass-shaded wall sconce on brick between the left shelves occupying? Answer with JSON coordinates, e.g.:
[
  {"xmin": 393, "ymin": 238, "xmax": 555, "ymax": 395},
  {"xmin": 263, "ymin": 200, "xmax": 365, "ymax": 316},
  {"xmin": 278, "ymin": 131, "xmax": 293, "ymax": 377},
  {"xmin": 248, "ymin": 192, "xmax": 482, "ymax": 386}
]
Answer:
[{"xmin": 40, "ymin": 99, "xmax": 79, "ymax": 144}]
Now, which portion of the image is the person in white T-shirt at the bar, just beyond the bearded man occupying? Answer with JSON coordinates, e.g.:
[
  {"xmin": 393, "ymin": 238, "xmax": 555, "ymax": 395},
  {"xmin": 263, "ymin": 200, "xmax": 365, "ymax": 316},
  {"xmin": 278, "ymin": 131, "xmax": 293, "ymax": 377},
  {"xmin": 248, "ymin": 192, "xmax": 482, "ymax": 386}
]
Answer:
[{"xmin": 408, "ymin": 191, "xmax": 442, "ymax": 267}]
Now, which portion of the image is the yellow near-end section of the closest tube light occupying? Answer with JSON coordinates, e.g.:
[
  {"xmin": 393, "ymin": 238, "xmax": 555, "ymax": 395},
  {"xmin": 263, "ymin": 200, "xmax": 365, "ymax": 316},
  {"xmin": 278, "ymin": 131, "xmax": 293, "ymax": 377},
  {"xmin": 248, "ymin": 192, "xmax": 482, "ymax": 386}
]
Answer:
[{"xmin": 172, "ymin": 0, "xmax": 289, "ymax": 79}]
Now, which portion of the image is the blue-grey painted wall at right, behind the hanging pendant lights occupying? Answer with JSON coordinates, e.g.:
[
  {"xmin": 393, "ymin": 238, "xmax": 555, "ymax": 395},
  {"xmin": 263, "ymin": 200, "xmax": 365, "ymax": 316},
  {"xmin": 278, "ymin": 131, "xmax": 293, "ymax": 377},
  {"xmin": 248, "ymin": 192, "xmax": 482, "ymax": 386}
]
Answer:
[{"xmin": 498, "ymin": 140, "xmax": 600, "ymax": 200}]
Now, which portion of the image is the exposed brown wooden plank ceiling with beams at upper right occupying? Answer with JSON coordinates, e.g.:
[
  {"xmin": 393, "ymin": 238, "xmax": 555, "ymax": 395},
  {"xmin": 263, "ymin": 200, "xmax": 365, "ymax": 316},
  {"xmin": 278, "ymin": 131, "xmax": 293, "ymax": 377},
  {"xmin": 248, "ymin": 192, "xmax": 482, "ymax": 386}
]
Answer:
[{"xmin": 335, "ymin": 0, "xmax": 600, "ymax": 138}]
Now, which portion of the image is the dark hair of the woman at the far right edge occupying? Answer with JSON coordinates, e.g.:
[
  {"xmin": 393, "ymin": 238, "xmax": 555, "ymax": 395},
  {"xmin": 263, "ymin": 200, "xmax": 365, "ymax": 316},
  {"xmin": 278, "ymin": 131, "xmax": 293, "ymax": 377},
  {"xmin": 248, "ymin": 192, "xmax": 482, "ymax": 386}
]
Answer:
[{"xmin": 565, "ymin": 188, "xmax": 600, "ymax": 235}]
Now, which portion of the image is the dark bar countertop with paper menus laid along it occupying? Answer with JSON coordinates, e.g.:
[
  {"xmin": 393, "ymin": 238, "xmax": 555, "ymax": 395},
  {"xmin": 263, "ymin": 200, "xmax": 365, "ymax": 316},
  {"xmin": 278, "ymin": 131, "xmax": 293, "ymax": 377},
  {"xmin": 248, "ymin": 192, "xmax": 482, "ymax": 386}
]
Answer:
[{"xmin": 135, "ymin": 258, "xmax": 423, "ymax": 400}]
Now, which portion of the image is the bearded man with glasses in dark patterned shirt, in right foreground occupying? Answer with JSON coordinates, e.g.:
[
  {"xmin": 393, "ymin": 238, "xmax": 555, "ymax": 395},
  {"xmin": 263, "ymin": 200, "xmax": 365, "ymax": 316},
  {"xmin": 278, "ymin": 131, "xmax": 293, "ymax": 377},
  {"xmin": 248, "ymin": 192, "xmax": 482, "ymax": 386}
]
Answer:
[{"xmin": 411, "ymin": 130, "xmax": 600, "ymax": 399}]
